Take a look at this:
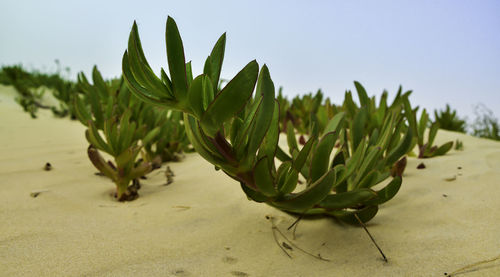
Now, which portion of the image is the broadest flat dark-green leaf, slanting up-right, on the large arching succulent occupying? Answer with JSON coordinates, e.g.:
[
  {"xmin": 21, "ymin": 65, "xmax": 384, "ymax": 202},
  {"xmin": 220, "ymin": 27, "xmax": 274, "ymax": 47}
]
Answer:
[{"xmin": 200, "ymin": 60, "xmax": 259, "ymax": 137}]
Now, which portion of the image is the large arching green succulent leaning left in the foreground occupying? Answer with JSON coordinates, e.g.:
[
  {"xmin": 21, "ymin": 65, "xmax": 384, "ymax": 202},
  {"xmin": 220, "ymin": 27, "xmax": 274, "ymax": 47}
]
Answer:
[{"xmin": 122, "ymin": 17, "xmax": 412, "ymax": 222}]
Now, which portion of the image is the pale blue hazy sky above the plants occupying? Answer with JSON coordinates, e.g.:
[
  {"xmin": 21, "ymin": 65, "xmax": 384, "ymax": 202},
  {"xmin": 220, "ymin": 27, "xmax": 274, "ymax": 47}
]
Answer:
[{"xmin": 0, "ymin": 0, "xmax": 500, "ymax": 119}]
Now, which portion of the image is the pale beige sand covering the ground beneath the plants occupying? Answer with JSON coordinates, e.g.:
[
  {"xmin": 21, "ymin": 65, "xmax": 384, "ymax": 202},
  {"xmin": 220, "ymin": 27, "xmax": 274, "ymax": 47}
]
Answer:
[{"xmin": 0, "ymin": 86, "xmax": 500, "ymax": 277}]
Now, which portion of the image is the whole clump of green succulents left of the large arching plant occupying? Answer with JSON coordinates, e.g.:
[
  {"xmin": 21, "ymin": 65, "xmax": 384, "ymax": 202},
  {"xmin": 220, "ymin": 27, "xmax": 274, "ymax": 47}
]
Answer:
[{"xmin": 74, "ymin": 67, "xmax": 189, "ymax": 201}]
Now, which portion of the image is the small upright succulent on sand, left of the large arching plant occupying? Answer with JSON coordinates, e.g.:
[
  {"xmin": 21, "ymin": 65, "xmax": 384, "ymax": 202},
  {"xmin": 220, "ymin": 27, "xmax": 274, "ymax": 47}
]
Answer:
[{"xmin": 74, "ymin": 67, "xmax": 160, "ymax": 201}]
